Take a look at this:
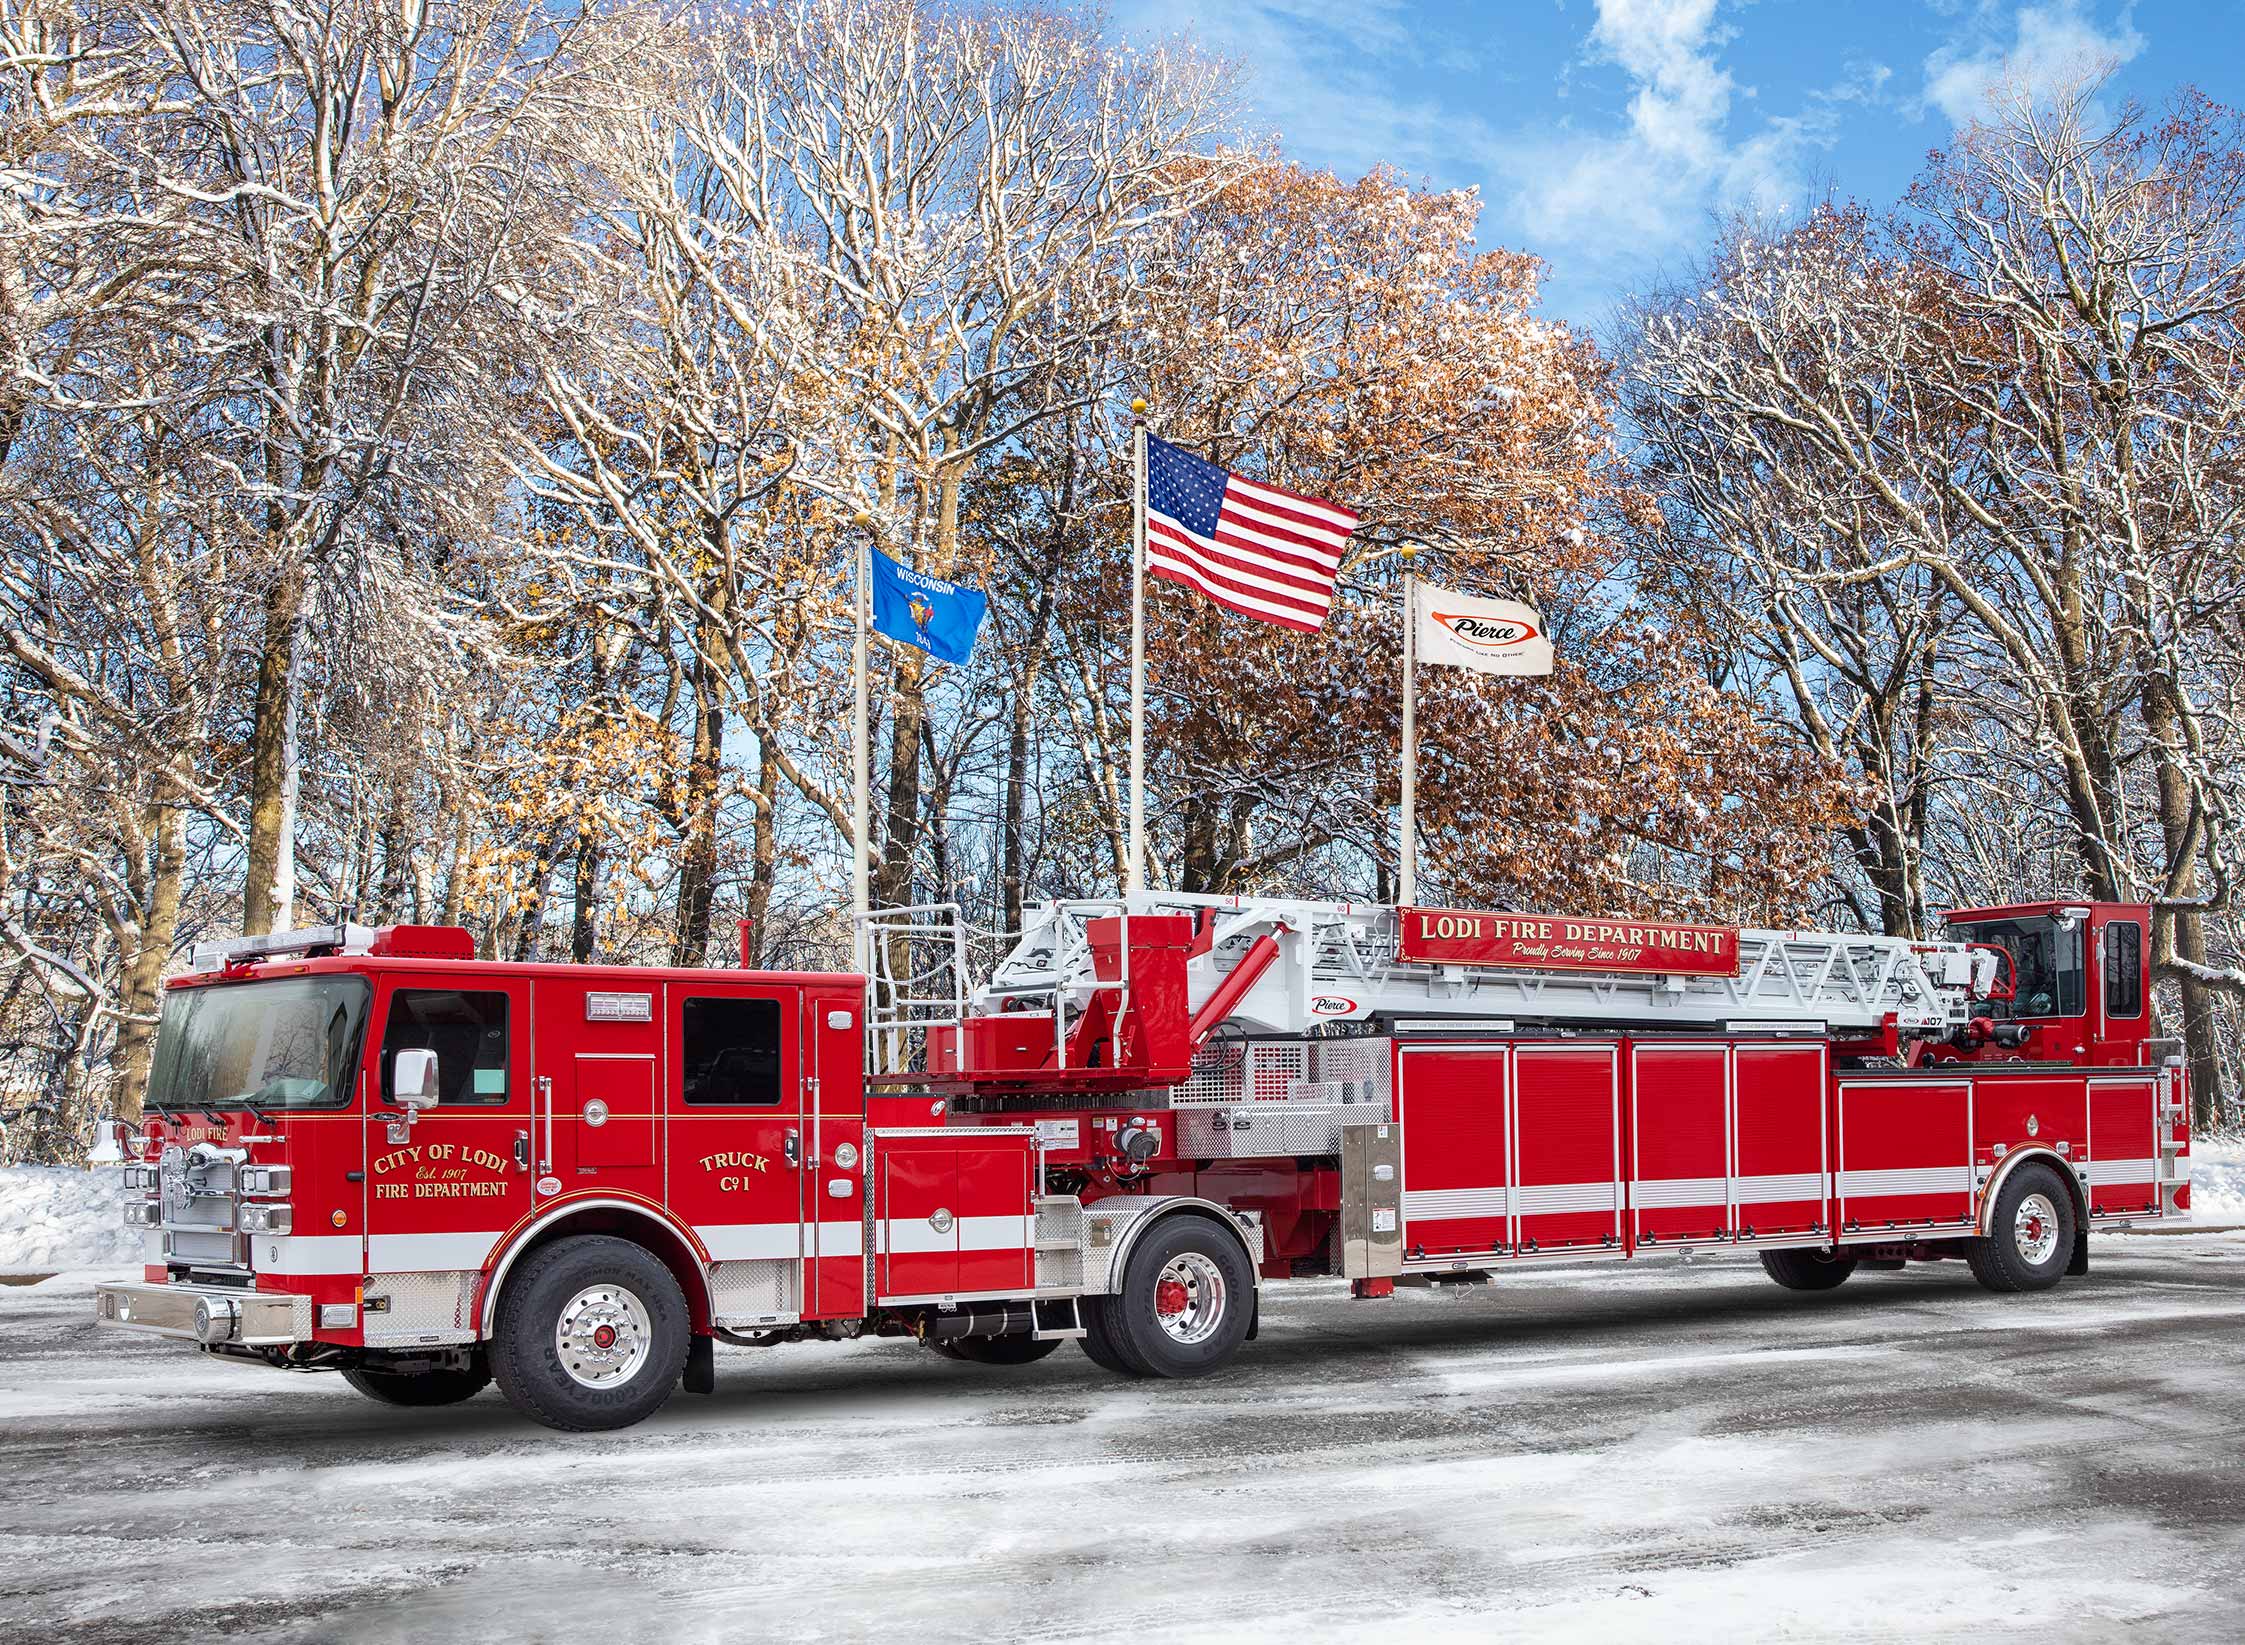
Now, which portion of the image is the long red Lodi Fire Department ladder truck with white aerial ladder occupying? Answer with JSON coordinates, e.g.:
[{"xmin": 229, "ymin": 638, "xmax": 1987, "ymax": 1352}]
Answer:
[{"xmin": 97, "ymin": 893, "xmax": 2189, "ymax": 1430}]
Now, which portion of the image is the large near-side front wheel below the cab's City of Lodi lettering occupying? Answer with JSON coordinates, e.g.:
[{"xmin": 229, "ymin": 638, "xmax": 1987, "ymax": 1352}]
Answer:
[{"xmin": 492, "ymin": 1234, "xmax": 689, "ymax": 1434}]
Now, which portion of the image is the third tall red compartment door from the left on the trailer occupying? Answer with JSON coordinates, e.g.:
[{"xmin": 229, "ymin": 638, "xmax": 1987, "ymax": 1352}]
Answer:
[{"xmin": 1630, "ymin": 1041, "xmax": 1731, "ymax": 1246}]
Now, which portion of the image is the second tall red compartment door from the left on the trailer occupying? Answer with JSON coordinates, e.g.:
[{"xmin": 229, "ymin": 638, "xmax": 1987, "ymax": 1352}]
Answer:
[{"xmin": 1508, "ymin": 1044, "xmax": 1621, "ymax": 1255}]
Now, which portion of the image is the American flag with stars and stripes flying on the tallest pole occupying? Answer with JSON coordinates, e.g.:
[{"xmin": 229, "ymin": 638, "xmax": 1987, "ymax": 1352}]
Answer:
[{"xmin": 1145, "ymin": 435, "xmax": 1356, "ymax": 633}]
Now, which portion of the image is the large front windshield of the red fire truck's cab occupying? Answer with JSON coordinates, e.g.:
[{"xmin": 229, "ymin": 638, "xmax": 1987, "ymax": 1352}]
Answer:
[{"xmin": 148, "ymin": 976, "xmax": 368, "ymax": 1111}]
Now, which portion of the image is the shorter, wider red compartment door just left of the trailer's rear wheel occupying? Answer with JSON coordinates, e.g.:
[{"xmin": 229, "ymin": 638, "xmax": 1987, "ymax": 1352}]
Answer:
[{"xmin": 1839, "ymin": 1077, "xmax": 1973, "ymax": 1239}]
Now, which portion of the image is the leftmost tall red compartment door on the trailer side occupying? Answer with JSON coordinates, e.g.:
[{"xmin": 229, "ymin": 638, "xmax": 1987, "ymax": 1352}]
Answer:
[{"xmin": 1396, "ymin": 1046, "xmax": 1513, "ymax": 1268}]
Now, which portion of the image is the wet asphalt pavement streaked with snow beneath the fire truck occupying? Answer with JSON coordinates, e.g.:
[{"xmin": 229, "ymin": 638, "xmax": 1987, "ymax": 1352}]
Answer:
[{"xmin": 0, "ymin": 1234, "xmax": 2245, "ymax": 1645}]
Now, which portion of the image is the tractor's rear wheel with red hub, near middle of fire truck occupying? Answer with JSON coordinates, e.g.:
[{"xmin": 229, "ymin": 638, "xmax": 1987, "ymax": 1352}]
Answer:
[{"xmin": 1100, "ymin": 1216, "xmax": 1255, "ymax": 1376}]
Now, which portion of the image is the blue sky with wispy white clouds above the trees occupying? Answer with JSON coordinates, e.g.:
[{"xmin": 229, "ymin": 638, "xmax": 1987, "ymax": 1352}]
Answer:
[{"xmin": 1111, "ymin": 0, "xmax": 2245, "ymax": 328}]
